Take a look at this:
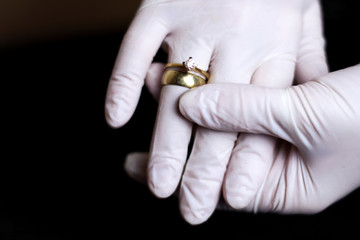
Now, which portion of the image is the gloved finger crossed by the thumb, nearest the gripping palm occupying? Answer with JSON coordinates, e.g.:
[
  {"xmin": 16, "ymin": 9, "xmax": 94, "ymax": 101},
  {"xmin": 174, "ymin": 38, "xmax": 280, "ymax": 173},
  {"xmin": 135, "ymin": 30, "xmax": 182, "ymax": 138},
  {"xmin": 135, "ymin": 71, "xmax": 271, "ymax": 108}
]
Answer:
[{"xmin": 223, "ymin": 58, "xmax": 295, "ymax": 209}]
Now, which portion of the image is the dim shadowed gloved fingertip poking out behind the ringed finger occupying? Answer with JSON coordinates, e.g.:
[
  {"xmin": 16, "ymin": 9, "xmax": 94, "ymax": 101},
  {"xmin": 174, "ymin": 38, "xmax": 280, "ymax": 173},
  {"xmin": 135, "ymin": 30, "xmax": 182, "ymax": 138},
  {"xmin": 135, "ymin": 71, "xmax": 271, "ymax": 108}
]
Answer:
[{"xmin": 124, "ymin": 152, "xmax": 149, "ymax": 184}]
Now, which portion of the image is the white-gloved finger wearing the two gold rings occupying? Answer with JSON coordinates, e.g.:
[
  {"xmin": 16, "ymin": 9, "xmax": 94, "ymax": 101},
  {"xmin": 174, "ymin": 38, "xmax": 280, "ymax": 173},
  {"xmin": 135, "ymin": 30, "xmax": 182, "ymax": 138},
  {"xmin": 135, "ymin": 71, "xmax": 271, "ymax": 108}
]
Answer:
[{"xmin": 148, "ymin": 48, "xmax": 211, "ymax": 197}]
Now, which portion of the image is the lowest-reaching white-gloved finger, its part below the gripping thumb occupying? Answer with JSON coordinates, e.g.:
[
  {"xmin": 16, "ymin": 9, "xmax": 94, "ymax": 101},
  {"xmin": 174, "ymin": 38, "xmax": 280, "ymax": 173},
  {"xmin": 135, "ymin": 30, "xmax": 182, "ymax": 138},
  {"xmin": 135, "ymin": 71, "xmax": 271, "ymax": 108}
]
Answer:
[{"xmin": 180, "ymin": 127, "xmax": 237, "ymax": 224}]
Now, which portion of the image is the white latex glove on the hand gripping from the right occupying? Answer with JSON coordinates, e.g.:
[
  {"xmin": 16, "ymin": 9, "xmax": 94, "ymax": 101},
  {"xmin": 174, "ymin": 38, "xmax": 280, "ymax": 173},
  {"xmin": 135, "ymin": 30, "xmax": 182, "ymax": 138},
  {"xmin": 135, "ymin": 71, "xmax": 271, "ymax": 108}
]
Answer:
[{"xmin": 180, "ymin": 65, "xmax": 360, "ymax": 213}]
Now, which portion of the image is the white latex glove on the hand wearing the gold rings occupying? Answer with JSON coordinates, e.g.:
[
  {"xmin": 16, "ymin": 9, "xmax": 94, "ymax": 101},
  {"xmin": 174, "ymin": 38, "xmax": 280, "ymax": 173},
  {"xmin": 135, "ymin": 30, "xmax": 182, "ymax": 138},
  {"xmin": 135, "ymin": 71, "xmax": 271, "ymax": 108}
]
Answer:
[{"xmin": 106, "ymin": 0, "xmax": 327, "ymax": 224}]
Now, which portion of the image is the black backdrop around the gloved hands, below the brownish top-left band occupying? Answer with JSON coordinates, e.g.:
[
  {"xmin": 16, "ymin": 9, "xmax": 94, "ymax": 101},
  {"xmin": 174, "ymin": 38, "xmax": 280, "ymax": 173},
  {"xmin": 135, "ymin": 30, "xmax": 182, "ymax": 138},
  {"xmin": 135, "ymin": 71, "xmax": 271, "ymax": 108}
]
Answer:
[{"xmin": 0, "ymin": 0, "xmax": 360, "ymax": 239}]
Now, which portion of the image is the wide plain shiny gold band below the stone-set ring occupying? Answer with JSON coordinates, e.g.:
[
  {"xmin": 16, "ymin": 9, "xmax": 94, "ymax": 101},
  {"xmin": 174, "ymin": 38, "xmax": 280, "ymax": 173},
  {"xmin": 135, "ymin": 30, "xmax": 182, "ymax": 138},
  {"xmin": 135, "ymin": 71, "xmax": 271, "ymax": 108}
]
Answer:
[{"xmin": 162, "ymin": 70, "xmax": 206, "ymax": 88}]
